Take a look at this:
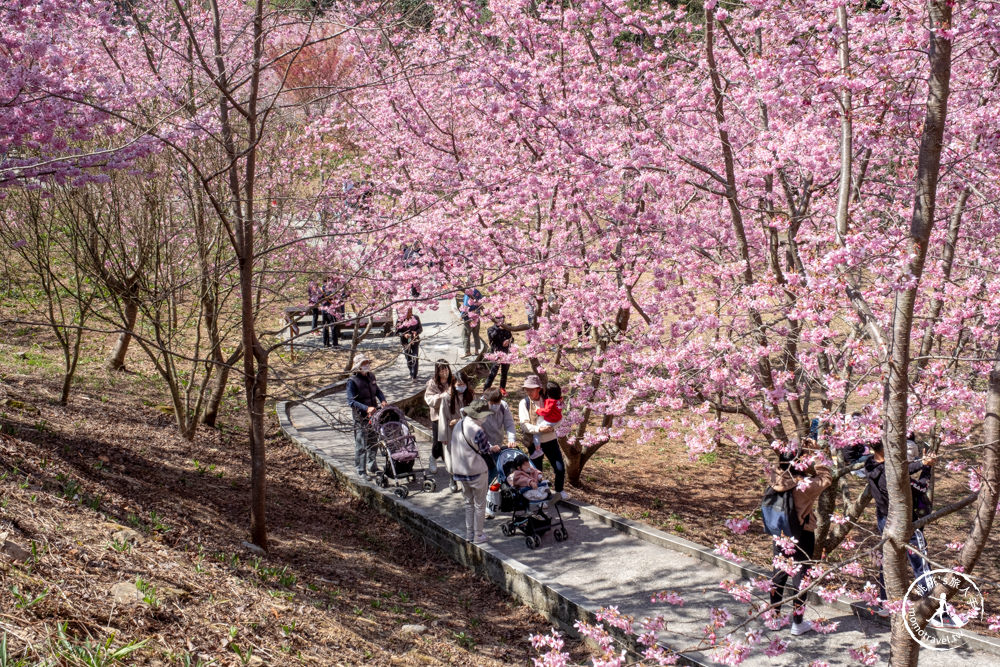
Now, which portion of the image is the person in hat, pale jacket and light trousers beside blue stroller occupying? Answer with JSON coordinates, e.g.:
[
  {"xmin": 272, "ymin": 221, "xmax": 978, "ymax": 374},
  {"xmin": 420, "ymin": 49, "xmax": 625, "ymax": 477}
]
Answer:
[{"xmin": 446, "ymin": 400, "xmax": 492, "ymax": 544}]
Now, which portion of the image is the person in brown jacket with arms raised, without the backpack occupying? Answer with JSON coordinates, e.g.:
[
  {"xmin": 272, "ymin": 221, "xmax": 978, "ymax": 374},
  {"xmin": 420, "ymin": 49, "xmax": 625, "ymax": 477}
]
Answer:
[{"xmin": 768, "ymin": 448, "xmax": 833, "ymax": 635}]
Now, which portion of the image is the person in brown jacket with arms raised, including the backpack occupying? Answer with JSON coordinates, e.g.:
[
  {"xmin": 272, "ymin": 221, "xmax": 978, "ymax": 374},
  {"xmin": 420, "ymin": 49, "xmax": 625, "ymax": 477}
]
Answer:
[{"xmin": 761, "ymin": 452, "xmax": 833, "ymax": 636}]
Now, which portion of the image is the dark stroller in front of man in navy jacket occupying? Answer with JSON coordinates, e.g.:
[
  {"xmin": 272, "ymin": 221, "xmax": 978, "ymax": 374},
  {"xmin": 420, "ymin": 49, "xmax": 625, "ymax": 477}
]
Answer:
[{"xmin": 370, "ymin": 405, "xmax": 437, "ymax": 498}]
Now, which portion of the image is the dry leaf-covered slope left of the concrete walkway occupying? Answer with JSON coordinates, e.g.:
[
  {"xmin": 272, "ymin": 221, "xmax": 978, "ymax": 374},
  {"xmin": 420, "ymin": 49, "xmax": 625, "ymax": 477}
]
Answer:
[{"xmin": 0, "ymin": 332, "xmax": 584, "ymax": 665}]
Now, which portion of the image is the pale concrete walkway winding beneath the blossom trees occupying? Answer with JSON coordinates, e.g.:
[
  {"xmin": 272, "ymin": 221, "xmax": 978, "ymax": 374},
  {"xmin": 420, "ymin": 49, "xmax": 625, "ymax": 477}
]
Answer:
[{"xmin": 278, "ymin": 300, "xmax": 1000, "ymax": 667}]
